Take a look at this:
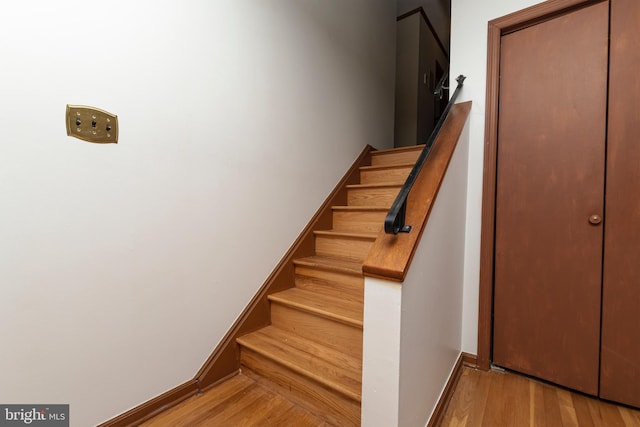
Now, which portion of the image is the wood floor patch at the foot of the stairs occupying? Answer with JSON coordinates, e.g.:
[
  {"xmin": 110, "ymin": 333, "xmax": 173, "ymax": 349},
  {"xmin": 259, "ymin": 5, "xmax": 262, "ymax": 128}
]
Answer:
[{"xmin": 141, "ymin": 374, "xmax": 328, "ymax": 427}]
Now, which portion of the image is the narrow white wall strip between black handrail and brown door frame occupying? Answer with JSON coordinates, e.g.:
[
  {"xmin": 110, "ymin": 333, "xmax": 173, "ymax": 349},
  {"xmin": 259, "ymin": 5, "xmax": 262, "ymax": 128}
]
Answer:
[{"xmin": 450, "ymin": 0, "xmax": 539, "ymax": 354}]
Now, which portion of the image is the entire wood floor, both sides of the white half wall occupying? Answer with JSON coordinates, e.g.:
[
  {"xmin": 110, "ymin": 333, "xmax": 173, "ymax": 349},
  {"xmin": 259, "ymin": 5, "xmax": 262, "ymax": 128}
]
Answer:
[{"xmin": 142, "ymin": 368, "xmax": 640, "ymax": 427}]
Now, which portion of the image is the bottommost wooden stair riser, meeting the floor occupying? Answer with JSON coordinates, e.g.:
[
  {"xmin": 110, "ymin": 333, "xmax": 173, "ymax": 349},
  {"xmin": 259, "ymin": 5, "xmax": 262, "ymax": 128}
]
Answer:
[{"xmin": 240, "ymin": 349, "xmax": 360, "ymax": 426}]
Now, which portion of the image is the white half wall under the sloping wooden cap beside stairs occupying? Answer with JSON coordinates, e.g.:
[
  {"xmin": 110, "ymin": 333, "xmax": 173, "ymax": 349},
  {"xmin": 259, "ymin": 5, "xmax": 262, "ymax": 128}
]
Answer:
[{"xmin": 362, "ymin": 114, "xmax": 469, "ymax": 427}]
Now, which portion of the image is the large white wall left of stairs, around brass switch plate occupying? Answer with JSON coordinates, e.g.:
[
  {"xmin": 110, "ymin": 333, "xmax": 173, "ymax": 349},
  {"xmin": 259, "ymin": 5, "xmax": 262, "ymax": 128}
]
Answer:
[{"xmin": 0, "ymin": 0, "xmax": 396, "ymax": 426}]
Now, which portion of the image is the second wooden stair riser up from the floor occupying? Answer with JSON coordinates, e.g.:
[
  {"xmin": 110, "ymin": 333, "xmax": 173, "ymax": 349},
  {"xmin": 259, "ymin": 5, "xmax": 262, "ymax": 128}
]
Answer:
[{"xmin": 271, "ymin": 302, "xmax": 362, "ymax": 359}]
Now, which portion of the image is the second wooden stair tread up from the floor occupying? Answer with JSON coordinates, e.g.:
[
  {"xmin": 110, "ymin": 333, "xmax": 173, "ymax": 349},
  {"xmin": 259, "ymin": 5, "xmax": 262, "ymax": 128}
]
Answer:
[{"xmin": 269, "ymin": 288, "xmax": 363, "ymax": 329}]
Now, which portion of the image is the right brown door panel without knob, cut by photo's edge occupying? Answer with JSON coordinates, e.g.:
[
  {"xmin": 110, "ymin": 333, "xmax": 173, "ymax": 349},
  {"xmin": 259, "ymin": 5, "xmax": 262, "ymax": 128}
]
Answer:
[{"xmin": 600, "ymin": 0, "xmax": 640, "ymax": 406}]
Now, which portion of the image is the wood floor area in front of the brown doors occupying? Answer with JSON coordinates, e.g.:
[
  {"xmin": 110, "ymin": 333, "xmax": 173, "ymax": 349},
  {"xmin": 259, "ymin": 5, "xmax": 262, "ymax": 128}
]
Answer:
[{"xmin": 440, "ymin": 368, "xmax": 640, "ymax": 427}]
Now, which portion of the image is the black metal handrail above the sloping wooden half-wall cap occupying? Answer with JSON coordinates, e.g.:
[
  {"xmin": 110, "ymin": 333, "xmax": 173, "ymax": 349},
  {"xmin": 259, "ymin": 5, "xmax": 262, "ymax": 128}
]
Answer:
[{"xmin": 384, "ymin": 74, "xmax": 466, "ymax": 234}]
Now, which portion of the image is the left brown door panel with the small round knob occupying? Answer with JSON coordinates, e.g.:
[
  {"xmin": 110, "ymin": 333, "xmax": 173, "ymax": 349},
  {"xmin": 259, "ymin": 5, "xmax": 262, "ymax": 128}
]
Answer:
[{"xmin": 493, "ymin": 3, "xmax": 609, "ymax": 395}]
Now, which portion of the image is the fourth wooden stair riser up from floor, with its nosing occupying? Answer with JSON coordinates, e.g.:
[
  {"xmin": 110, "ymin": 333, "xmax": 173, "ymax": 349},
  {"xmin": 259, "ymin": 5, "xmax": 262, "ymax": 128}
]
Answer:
[{"xmin": 313, "ymin": 230, "xmax": 378, "ymax": 261}]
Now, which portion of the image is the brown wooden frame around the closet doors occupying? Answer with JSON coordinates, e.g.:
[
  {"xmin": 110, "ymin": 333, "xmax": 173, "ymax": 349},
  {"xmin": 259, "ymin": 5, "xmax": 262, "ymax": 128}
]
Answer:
[{"xmin": 477, "ymin": 0, "xmax": 608, "ymax": 370}]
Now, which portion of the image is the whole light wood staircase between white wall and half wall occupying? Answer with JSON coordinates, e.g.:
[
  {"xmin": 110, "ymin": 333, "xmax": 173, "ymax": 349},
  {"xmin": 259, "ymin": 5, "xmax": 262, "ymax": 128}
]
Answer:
[{"xmin": 237, "ymin": 146, "xmax": 423, "ymax": 426}]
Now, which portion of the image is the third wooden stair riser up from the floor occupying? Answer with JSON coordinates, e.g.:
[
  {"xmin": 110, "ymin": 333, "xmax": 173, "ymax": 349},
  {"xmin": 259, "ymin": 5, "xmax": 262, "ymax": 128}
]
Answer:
[{"xmin": 295, "ymin": 267, "xmax": 364, "ymax": 302}]
